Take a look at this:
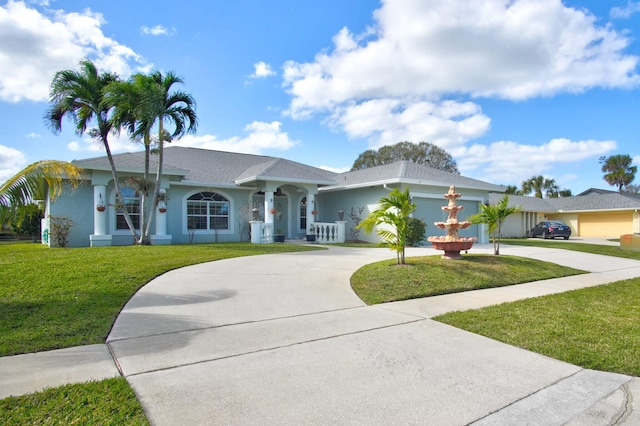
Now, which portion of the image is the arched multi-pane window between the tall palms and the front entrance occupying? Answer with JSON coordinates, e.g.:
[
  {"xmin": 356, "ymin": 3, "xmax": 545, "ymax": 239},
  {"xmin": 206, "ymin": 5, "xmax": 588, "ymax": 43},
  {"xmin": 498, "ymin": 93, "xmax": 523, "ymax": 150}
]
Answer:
[{"xmin": 187, "ymin": 192, "xmax": 229, "ymax": 231}]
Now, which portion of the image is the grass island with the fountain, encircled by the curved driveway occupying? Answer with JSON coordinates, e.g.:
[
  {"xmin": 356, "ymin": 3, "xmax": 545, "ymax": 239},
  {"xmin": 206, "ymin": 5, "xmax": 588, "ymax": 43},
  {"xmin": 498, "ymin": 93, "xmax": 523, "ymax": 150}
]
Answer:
[{"xmin": 351, "ymin": 255, "xmax": 585, "ymax": 305}]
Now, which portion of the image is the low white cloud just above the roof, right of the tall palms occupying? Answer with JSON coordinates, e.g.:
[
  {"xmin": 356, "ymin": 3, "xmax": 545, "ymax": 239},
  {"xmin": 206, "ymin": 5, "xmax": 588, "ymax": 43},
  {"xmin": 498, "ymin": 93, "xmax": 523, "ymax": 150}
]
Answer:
[{"xmin": 171, "ymin": 121, "xmax": 298, "ymax": 154}]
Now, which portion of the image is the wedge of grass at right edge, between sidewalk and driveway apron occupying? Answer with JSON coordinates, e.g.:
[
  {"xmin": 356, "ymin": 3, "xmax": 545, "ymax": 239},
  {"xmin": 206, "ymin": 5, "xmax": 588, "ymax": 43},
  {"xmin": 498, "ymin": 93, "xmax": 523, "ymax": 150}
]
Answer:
[{"xmin": 434, "ymin": 278, "xmax": 640, "ymax": 376}]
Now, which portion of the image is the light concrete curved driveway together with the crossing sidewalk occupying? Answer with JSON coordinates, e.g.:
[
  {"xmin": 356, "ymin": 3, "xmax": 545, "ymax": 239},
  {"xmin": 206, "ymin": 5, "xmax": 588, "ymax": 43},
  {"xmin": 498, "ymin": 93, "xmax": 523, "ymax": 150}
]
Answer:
[{"xmin": 0, "ymin": 241, "xmax": 640, "ymax": 425}]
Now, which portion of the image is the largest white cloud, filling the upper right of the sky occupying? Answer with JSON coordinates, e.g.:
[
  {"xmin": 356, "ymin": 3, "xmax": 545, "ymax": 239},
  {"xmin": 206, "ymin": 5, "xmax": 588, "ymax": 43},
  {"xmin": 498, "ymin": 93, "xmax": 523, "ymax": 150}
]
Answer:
[{"xmin": 284, "ymin": 0, "xmax": 639, "ymax": 118}]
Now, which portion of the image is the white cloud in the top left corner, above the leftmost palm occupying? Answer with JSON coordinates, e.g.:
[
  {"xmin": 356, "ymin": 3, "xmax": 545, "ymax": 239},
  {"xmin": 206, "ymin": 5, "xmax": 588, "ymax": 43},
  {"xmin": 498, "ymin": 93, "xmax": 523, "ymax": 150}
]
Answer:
[{"xmin": 0, "ymin": 0, "xmax": 150, "ymax": 102}]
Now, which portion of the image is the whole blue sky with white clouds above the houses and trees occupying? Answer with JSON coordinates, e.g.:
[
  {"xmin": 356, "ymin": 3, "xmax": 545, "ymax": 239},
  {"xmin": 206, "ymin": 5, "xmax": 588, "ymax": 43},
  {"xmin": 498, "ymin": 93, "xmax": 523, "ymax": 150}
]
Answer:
[{"xmin": 0, "ymin": 0, "xmax": 640, "ymax": 194}]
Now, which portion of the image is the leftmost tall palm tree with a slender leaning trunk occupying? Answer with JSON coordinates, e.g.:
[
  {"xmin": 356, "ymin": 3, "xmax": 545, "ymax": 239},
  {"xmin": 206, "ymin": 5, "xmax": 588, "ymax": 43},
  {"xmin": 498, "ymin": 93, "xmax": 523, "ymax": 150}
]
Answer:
[{"xmin": 44, "ymin": 59, "xmax": 136, "ymax": 240}]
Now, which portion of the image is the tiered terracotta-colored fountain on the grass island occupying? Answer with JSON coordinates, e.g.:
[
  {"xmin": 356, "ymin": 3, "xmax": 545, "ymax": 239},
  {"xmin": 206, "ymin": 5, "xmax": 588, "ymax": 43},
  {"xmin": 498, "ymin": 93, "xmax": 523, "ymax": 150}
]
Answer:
[{"xmin": 427, "ymin": 185, "xmax": 477, "ymax": 259}]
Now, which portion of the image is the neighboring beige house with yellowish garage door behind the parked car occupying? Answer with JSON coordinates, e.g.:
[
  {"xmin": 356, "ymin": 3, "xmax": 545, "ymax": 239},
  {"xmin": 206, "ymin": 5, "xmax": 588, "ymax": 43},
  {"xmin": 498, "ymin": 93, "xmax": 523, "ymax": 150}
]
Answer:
[{"xmin": 489, "ymin": 188, "xmax": 640, "ymax": 238}]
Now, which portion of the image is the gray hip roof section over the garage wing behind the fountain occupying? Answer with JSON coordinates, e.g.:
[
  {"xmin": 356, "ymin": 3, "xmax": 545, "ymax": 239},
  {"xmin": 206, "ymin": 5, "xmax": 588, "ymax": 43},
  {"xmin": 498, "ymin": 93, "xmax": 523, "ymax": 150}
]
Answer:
[{"xmin": 325, "ymin": 161, "xmax": 505, "ymax": 192}]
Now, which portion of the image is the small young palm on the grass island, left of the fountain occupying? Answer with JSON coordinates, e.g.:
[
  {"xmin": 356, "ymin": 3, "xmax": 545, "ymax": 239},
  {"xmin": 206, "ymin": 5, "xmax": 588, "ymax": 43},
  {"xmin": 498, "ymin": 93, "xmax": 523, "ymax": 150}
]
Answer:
[{"xmin": 357, "ymin": 188, "xmax": 417, "ymax": 265}]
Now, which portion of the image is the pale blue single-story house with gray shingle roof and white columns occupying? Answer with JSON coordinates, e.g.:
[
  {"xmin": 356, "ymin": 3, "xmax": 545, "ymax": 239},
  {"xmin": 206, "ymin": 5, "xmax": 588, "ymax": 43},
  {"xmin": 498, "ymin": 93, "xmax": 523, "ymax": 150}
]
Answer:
[{"xmin": 43, "ymin": 147, "xmax": 504, "ymax": 247}]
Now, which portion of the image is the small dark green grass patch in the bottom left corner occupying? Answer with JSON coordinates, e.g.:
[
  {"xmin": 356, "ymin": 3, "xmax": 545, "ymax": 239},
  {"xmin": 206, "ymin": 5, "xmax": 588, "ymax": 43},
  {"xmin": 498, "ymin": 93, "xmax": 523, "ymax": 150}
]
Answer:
[{"xmin": 0, "ymin": 378, "xmax": 149, "ymax": 426}]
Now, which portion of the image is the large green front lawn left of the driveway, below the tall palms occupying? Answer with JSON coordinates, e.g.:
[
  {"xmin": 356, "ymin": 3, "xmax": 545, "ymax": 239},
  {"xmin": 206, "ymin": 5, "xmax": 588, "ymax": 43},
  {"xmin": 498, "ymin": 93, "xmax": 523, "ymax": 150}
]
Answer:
[{"xmin": 0, "ymin": 243, "xmax": 315, "ymax": 356}]
